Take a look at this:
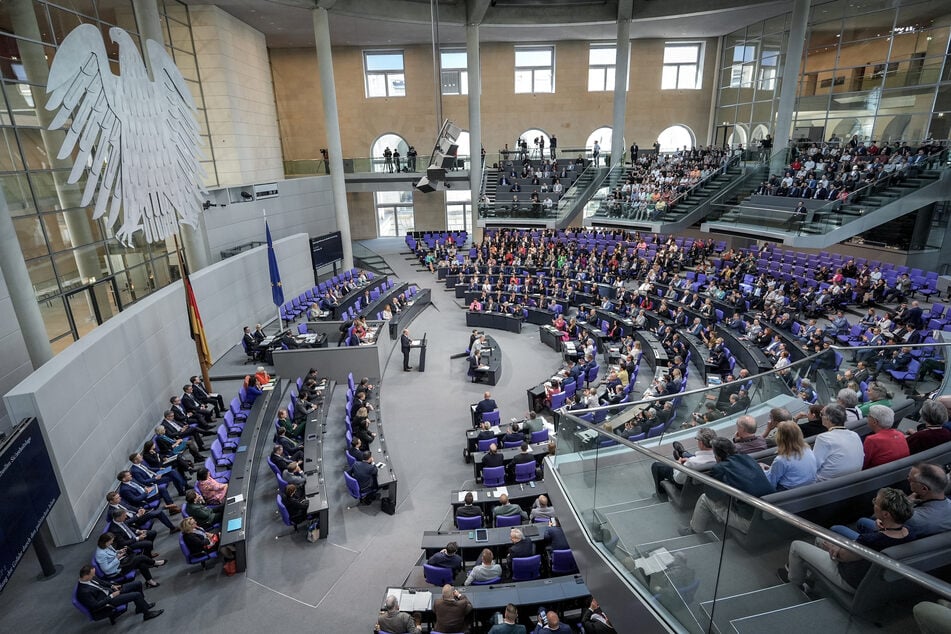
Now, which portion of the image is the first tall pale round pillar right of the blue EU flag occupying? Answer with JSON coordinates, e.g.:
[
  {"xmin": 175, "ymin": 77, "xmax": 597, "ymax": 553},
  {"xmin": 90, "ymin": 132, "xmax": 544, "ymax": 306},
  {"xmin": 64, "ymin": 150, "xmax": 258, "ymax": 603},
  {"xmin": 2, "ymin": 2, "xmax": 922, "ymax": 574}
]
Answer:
[{"xmin": 314, "ymin": 7, "xmax": 353, "ymax": 269}]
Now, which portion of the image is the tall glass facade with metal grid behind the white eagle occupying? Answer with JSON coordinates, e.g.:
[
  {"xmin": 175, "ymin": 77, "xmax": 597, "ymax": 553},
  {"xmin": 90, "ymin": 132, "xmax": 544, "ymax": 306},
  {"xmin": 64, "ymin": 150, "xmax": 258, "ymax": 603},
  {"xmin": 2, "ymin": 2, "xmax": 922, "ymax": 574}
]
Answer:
[{"xmin": 0, "ymin": 0, "xmax": 217, "ymax": 352}]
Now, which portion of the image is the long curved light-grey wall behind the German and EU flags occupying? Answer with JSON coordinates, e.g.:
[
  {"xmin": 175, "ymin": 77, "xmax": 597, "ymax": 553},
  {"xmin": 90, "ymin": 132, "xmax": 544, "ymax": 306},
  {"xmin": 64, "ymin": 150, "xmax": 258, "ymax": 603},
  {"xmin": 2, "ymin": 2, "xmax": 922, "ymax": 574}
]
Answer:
[{"xmin": 0, "ymin": 235, "xmax": 313, "ymax": 546}]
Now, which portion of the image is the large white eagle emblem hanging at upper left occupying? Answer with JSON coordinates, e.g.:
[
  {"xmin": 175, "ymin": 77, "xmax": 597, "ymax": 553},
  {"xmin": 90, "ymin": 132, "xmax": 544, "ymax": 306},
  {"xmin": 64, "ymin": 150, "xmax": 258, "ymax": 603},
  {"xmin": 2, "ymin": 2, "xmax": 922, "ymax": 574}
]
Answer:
[{"xmin": 46, "ymin": 24, "xmax": 205, "ymax": 245}]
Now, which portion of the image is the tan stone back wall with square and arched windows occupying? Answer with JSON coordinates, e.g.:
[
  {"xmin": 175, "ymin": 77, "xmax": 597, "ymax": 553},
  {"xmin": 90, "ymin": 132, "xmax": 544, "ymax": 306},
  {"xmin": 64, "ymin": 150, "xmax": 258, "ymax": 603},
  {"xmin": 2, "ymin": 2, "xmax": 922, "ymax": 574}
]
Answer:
[{"xmin": 271, "ymin": 39, "xmax": 717, "ymax": 160}]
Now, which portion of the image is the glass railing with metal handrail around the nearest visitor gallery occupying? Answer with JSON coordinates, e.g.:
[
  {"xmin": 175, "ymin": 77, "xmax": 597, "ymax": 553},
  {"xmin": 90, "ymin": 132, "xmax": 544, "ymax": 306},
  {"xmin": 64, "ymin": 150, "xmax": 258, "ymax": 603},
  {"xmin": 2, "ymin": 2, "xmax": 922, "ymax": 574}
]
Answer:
[{"xmin": 546, "ymin": 343, "xmax": 951, "ymax": 634}]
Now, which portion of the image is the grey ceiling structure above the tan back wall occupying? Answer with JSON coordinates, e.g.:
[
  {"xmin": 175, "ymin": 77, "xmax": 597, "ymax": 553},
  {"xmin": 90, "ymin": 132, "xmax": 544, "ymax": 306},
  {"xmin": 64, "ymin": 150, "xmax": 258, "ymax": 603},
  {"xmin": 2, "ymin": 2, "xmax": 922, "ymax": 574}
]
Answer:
[{"xmin": 184, "ymin": 0, "xmax": 790, "ymax": 48}]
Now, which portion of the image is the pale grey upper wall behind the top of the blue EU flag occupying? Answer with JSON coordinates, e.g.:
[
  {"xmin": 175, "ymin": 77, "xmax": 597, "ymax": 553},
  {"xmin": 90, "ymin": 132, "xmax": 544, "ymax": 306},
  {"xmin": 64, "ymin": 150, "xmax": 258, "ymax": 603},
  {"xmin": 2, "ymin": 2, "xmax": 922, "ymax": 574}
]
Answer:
[{"xmin": 202, "ymin": 176, "xmax": 340, "ymax": 261}]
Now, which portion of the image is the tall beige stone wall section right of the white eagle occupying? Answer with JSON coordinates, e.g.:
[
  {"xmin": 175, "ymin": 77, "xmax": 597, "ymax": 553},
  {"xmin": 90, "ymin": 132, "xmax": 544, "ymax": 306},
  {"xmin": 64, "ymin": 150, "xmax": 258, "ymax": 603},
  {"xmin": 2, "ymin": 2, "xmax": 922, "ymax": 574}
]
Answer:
[{"xmin": 189, "ymin": 5, "xmax": 284, "ymax": 185}]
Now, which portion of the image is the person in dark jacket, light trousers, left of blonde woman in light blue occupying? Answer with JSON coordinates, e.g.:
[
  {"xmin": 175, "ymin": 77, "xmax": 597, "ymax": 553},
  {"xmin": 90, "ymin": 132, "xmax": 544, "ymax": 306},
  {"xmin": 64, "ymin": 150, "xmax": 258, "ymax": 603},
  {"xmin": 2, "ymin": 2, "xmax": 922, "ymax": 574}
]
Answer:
[{"xmin": 680, "ymin": 438, "xmax": 776, "ymax": 535}]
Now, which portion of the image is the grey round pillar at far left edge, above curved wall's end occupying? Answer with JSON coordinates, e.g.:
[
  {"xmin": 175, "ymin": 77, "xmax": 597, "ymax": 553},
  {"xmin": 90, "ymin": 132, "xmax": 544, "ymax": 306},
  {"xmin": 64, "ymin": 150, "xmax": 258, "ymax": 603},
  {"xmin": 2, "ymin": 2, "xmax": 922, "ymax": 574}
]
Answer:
[{"xmin": 0, "ymin": 189, "xmax": 53, "ymax": 370}]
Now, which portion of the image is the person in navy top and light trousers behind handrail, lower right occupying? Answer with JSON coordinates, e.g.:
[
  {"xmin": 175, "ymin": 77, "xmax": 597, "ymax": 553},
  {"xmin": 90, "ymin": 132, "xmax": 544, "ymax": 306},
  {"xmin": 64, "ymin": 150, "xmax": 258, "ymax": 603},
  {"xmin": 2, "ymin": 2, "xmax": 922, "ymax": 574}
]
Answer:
[{"xmin": 779, "ymin": 488, "xmax": 917, "ymax": 593}]
